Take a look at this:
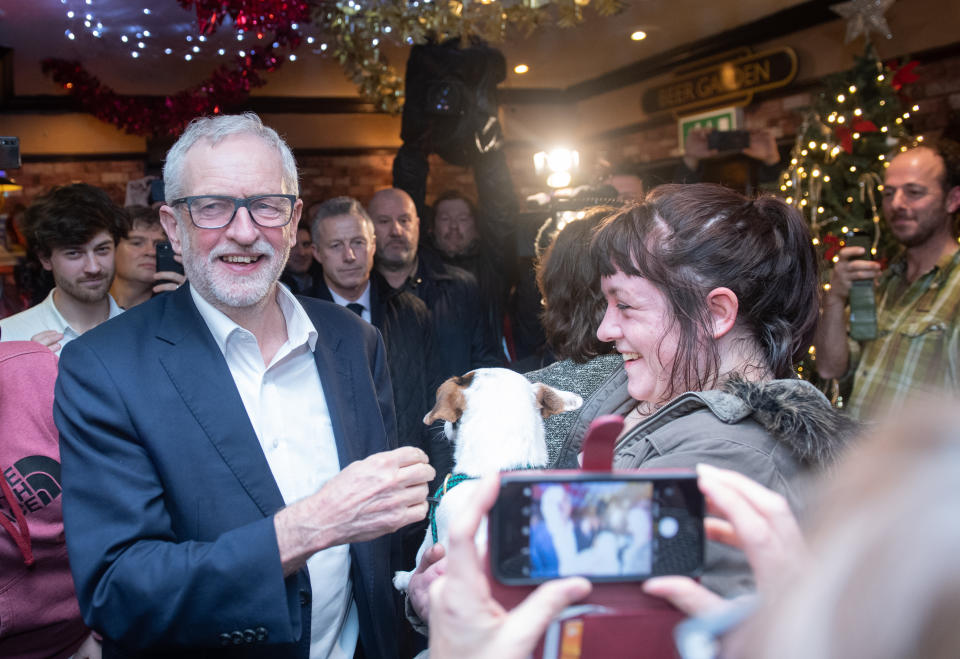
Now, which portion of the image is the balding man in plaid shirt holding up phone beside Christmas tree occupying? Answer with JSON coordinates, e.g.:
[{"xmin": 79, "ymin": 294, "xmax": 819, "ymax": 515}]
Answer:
[{"xmin": 816, "ymin": 140, "xmax": 960, "ymax": 419}]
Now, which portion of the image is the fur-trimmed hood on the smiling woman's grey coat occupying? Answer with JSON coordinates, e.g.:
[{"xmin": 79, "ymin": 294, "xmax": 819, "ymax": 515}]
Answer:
[{"xmin": 698, "ymin": 377, "xmax": 860, "ymax": 466}]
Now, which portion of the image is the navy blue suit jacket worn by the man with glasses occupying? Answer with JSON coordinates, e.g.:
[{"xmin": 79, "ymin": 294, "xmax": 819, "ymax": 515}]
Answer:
[{"xmin": 54, "ymin": 286, "xmax": 399, "ymax": 659}]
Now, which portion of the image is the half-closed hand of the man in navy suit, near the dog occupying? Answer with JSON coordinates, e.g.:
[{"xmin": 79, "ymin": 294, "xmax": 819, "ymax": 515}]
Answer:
[{"xmin": 274, "ymin": 446, "xmax": 434, "ymax": 575}]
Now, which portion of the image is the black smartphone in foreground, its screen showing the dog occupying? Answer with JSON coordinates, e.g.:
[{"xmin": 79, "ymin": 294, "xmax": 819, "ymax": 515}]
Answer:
[{"xmin": 488, "ymin": 472, "xmax": 705, "ymax": 585}]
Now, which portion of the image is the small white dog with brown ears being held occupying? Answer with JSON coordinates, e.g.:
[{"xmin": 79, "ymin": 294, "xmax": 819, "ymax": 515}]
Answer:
[{"xmin": 393, "ymin": 368, "xmax": 583, "ymax": 591}]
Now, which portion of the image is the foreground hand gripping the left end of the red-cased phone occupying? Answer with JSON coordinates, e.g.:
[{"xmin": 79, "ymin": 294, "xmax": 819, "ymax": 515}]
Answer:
[{"xmin": 430, "ymin": 478, "xmax": 590, "ymax": 659}]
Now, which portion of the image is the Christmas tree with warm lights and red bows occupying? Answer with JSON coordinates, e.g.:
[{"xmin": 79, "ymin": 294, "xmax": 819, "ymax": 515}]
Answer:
[{"xmin": 779, "ymin": 42, "xmax": 922, "ymax": 380}]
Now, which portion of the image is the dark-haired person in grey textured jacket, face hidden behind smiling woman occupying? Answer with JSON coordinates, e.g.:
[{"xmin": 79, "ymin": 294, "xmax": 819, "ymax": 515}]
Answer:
[{"xmin": 525, "ymin": 207, "xmax": 627, "ymax": 469}]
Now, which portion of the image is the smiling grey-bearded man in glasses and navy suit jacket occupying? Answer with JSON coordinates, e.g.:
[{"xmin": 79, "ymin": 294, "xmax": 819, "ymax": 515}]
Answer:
[{"xmin": 54, "ymin": 114, "xmax": 434, "ymax": 659}]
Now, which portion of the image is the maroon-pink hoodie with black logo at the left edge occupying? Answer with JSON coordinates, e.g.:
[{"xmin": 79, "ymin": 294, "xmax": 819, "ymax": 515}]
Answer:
[{"xmin": 0, "ymin": 341, "xmax": 89, "ymax": 659}]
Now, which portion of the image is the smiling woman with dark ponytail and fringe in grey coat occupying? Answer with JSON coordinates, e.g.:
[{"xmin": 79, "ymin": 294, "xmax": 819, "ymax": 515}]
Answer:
[{"xmin": 548, "ymin": 184, "xmax": 854, "ymax": 596}]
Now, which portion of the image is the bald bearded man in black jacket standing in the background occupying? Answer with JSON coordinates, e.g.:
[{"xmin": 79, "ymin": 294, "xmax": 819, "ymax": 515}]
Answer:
[{"xmin": 370, "ymin": 188, "xmax": 503, "ymax": 378}]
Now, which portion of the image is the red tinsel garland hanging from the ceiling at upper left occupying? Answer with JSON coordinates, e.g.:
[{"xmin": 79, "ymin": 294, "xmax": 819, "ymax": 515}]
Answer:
[{"xmin": 41, "ymin": 0, "xmax": 309, "ymax": 135}]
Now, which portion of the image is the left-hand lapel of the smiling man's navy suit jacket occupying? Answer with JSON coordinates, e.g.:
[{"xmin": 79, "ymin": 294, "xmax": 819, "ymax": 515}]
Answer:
[{"xmin": 157, "ymin": 286, "xmax": 284, "ymax": 516}]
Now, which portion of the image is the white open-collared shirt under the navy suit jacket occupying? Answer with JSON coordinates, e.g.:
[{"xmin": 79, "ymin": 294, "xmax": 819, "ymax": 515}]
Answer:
[{"xmin": 190, "ymin": 286, "xmax": 360, "ymax": 659}]
